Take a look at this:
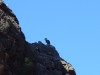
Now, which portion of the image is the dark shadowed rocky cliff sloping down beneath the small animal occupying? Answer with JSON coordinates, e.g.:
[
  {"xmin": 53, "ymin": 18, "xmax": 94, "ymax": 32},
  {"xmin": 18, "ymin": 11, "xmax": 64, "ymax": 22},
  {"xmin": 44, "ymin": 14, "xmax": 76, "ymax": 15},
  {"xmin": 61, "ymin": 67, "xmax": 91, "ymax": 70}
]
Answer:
[{"xmin": 0, "ymin": 2, "xmax": 76, "ymax": 75}]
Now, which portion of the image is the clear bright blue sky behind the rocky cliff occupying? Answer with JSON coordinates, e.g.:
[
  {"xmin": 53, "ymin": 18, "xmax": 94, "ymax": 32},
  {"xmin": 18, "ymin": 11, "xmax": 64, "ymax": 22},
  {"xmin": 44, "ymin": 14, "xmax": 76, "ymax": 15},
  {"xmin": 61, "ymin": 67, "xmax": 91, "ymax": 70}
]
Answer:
[{"xmin": 4, "ymin": 0, "xmax": 100, "ymax": 75}]
